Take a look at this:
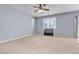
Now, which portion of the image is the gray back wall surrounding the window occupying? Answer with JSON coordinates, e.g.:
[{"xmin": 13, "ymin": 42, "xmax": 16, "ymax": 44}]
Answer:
[{"xmin": 36, "ymin": 11, "xmax": 79, "ymax": 36}]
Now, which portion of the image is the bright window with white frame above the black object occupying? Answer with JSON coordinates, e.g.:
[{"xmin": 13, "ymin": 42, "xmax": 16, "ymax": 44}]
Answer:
[{"xmin": 43, "ymin": 17, "xmax": 56, "ymax": 29}]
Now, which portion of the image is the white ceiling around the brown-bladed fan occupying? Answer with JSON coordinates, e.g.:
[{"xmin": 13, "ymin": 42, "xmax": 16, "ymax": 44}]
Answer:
[{"xmin": 8, "ymin": 4, "xmax": 79, "ymax": 17}]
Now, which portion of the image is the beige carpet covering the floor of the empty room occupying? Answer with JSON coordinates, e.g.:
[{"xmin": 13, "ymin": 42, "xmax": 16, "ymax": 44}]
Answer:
[{"xmin": 0, "ymin": 36, "xmax": 79, "ymax": 54}]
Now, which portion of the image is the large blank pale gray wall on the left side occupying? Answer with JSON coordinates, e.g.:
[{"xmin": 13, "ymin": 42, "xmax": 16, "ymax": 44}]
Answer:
[{"xmin": 0, "ymin": 5, "xmax": 33, "ymax": 41}]
